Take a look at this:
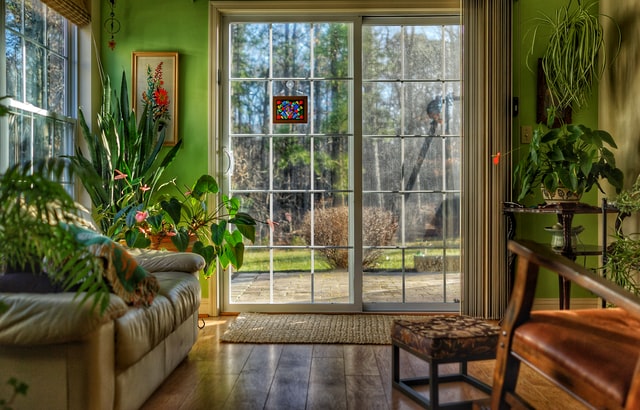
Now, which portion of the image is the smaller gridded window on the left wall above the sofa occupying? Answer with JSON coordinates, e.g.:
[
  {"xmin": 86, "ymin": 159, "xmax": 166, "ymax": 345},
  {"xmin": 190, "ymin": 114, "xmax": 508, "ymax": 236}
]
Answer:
[{"xmin": 0, "ymin": 0, "xmax": 77, "ymax": 191}]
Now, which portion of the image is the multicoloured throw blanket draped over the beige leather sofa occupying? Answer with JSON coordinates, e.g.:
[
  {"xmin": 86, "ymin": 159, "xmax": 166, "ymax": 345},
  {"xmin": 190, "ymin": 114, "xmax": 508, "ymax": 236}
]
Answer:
[{"xmin": 67, "ymin": 225, "xmax": 159, "ymax": 306}]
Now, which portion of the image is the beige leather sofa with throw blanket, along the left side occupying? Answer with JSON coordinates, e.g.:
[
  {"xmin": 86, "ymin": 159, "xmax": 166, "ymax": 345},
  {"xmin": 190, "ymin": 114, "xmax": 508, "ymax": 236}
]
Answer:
[{"xmin": 0, "ymin": 251, "xmax": 204, "ymax": 410}]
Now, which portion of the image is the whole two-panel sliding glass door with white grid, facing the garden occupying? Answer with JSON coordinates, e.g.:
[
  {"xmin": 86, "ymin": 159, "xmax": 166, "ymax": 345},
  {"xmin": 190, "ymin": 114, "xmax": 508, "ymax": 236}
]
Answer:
[{"xmin": 221, "ymin": 15, "xmax": 462, "ymax": 311}]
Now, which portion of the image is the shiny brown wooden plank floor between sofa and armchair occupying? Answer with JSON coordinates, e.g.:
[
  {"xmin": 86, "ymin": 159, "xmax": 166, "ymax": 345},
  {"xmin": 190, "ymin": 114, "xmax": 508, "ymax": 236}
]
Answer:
[{"xmin": 143, "ymin": 316, "xmax": 585, "ymax": 410}]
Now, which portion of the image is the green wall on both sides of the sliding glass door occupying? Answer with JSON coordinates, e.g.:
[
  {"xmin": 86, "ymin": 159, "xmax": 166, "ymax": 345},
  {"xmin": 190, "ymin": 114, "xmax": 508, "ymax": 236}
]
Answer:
[{"xmin": 101, "ymin": 0, "xmax": 598, "ymax": 297}]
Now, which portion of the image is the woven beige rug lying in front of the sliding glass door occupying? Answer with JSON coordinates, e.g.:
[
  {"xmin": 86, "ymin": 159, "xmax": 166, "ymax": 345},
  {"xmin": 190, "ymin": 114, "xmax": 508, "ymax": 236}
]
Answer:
[{"xmin": 220, "ymin": 313, "xmax": 420, "ymax": 344}]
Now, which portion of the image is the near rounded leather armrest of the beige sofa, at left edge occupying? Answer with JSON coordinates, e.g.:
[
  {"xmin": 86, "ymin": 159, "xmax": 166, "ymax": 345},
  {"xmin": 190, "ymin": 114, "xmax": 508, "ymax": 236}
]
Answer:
[{"xmin": 0, "ymin": 292, "xmax": 127, "ymax": 346}]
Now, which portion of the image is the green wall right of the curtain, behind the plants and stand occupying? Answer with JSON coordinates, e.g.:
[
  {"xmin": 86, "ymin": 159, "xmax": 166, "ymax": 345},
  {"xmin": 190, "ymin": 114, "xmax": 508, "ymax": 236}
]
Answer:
[{"xmin": 512, "ymin": 0, "xmax": 599, "ymax": 298}]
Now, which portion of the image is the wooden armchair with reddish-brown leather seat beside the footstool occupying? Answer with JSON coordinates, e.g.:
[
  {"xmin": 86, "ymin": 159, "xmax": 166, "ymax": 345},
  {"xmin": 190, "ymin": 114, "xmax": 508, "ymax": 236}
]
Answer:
[{"xmin": 491, "ymin": 241, "xmax": 640, "ymax": 409}]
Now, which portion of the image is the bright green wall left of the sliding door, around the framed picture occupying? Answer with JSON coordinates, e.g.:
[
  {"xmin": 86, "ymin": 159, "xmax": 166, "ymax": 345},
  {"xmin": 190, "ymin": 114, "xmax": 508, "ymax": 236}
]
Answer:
[{"xmin": 100, "ymin": 0, "xmax": 209, "ymax": 186}]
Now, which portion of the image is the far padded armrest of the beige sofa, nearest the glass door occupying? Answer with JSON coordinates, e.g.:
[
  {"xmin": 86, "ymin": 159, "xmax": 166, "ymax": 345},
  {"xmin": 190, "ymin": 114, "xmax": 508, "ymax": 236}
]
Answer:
[{"xmin": 128, "ymin": 249, "xmax": 205, "ymax": 273}]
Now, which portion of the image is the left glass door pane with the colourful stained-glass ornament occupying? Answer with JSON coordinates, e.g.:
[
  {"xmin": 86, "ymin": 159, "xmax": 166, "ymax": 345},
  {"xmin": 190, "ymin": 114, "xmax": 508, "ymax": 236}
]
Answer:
[{"xmin": 223, "ymin": 22, "xmax": 354, "ymax": 311}]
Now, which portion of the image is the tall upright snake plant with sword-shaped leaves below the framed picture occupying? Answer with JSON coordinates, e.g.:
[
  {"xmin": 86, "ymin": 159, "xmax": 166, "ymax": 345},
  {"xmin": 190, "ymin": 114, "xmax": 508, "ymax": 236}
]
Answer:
[{"xmin": 70, "ymin": 72, "xmax": 182, "ymax": 240}]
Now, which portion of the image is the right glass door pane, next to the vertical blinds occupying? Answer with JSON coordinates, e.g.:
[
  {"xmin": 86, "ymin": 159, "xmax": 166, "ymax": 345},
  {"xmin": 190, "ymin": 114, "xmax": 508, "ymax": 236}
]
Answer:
[{"xmin": 362, "ymin": 21, "xmax": 461, "ymax": 310}]
